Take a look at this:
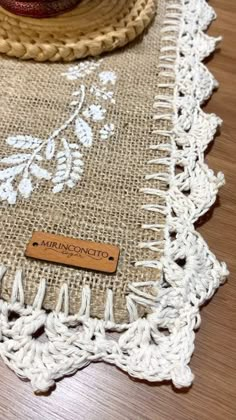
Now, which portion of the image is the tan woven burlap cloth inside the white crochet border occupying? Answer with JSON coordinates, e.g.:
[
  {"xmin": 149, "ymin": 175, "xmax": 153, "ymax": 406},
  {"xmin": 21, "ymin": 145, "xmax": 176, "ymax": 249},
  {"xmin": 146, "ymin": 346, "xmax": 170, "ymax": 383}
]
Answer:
[{"xmin": 1, "ymin": 0, "xmax": 164, "ymax": 322}]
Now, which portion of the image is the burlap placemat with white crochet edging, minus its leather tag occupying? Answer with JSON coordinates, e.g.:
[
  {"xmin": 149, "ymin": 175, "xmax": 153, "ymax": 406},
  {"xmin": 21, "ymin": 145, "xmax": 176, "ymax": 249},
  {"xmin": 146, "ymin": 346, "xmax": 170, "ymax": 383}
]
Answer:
[{"xmin": 0, "ymin": 0, "xmax": 226, "ymax": 391}]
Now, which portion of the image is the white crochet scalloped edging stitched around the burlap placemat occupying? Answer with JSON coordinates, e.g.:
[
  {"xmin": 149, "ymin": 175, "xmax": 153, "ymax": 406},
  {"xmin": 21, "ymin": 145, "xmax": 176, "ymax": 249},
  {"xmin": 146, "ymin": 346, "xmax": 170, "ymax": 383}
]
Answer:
[{"xmin": 0, "ymin": 0, "xmax": 228, "ymax": 392}]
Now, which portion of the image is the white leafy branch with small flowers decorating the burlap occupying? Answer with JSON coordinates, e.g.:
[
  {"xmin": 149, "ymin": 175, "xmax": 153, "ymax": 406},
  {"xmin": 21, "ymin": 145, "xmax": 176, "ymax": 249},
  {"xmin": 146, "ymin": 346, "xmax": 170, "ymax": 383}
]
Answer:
[{"xmin": 0, "ymin": 60, "xmax": 116, "ymax": 204}]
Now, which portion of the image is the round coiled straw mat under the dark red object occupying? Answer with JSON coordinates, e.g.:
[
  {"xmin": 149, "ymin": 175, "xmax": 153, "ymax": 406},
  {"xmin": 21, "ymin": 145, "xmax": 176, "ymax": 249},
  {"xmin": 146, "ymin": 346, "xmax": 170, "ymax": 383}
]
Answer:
[{"xmin": 0, "ymin": 0, "xmax": 156, "ymax": 61}]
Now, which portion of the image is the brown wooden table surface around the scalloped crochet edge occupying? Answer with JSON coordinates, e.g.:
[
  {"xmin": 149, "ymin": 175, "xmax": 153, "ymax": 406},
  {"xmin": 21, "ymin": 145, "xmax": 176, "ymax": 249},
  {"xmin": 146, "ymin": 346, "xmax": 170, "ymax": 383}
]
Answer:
[{"xmin": 0, "ymin": 0, "xmax": 236, "ymax": 420}]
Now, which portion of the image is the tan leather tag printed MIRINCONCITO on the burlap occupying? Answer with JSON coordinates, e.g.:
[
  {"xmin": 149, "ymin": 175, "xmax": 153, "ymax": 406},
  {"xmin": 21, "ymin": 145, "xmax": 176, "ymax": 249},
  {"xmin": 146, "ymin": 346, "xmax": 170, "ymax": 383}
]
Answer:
[{"xmin": 25, "ymin": 232, "xmax": 120, "ymax": 273}]
